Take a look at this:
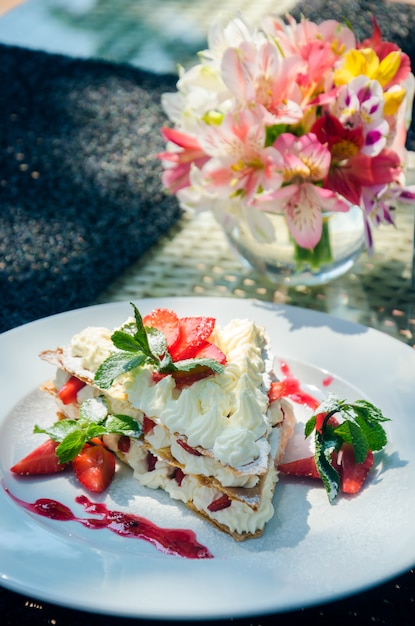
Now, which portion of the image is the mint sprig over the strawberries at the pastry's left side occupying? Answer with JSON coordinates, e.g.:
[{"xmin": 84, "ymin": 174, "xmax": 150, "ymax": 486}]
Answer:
[{"xmin": 33, "ymin": 397, "xmax": 141, "ymax": 463}]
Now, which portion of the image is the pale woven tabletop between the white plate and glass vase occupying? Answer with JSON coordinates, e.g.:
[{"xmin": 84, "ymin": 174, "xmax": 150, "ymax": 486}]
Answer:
[{"xmin": 96, "ymin": 206, "xmax": 415, "ymax": 345}]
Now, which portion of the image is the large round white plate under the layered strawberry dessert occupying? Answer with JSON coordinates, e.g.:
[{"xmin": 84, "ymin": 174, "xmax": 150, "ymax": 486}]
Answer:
[{"xmin": 0, "ymin": 298, "xmax": 415, "ymax": 619}]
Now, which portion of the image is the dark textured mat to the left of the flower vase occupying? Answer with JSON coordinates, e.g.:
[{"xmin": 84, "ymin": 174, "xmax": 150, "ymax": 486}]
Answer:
[{"xmin": 0, "ymin": 46, "xmax": 180, "ymax": 331}]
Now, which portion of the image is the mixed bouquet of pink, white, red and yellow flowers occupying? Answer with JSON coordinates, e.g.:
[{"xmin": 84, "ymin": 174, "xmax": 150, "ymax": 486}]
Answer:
[{"xmin": 158, "ymin": 15, "xmax": 415, "ymax": 280}]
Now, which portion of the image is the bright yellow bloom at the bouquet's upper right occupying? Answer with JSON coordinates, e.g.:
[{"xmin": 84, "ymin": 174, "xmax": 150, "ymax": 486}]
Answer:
[{"xmin": 334, "ymin": 48, "xmax": 406, "ymax": 115}]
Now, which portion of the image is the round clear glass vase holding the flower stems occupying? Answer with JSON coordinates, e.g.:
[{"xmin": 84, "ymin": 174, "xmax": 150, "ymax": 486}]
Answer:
[{"xmin": 221, "ymin": 205, "xmax": 364, "ymax": 286}]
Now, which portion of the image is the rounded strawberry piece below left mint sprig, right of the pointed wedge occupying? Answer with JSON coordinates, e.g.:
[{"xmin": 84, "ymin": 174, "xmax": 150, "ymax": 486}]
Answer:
[{"xmin": 72, "ymin": 444, "xmax": 115, "ymax": 493}]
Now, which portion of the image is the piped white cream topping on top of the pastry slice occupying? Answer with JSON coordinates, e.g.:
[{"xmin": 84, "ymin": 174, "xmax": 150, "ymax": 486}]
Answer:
[{"xmin": 63, "ymin": 319, "xmax": 273, "ymax": 468}]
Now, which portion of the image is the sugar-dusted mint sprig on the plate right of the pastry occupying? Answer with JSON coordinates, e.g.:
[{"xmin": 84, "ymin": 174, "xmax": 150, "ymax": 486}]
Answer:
[{"xmin": 304, "ymin": 394, "xmax": 389, "ymax": 502}]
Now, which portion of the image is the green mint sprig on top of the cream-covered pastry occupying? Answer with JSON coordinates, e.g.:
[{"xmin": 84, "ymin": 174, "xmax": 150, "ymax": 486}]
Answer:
[{"xmin": 94, "ymin": 302, "xmax": 224, "ymax": 389}]
